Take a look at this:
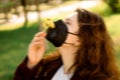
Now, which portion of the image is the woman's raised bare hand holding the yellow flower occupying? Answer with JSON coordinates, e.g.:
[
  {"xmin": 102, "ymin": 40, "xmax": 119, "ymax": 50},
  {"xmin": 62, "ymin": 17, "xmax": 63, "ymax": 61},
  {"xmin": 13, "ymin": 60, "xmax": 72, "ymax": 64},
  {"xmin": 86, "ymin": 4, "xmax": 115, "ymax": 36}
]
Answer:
[{"xmin": 27, "ymin": 32, "xmax": 46, "ymax": 68}]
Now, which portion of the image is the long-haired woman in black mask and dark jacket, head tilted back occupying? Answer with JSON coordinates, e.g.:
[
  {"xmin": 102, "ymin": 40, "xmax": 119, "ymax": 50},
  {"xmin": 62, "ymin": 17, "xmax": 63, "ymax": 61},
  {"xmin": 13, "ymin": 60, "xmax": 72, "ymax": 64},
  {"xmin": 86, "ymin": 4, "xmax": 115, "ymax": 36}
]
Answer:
[{"xmin": 14, "ymin": 9, "xmax": 119, "ymax": 80}]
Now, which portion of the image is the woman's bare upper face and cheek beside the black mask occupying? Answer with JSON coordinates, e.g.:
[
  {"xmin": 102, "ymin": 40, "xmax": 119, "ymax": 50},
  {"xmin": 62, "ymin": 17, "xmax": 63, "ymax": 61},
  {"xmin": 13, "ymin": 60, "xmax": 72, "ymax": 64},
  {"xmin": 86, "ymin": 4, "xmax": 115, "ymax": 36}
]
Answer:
[{"xmin": 63, "ymin": 12, "xmax": 80, "ymax": 45}]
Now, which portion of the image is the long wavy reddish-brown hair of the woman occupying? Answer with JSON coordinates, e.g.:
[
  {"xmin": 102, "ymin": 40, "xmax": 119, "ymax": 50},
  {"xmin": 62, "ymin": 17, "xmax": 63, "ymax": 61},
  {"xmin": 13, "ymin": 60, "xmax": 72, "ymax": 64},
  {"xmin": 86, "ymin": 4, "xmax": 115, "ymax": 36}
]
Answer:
[{"xmin": 74, "ymin": 9, "xmax": 119, "ymax": 80}]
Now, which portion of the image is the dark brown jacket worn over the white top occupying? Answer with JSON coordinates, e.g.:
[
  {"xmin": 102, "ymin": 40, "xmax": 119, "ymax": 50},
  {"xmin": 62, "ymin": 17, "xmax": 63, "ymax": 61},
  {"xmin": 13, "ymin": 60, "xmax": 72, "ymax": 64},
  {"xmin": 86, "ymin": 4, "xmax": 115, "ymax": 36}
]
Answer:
[{"xmin": 13, "ymin": 53, "xmax": 107, "ymax": 80}]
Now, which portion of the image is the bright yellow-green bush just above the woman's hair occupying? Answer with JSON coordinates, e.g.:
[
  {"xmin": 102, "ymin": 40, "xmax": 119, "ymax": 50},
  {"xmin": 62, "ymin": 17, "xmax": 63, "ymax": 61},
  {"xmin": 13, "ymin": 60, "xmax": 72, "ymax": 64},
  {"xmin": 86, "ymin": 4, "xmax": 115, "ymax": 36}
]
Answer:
[{"xmin": 89, "ymin": 2, "xmax": 112, "ymax": 16}]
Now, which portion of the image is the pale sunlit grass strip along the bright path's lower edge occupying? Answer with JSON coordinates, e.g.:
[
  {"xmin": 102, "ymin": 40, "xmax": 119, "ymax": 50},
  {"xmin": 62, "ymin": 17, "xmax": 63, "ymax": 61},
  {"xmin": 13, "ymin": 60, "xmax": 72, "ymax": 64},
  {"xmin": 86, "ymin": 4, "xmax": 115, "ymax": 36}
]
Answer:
[{"xmin": 0, "ymin": 12, "xmax": 70, "ymax": 31}]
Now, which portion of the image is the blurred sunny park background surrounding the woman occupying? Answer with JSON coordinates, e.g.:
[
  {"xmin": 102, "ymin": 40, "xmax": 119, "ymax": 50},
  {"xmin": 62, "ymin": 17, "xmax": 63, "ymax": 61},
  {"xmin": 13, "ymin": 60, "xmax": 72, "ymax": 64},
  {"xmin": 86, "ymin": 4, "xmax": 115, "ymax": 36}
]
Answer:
[{"xmin": 0, "ymin": 0, "xmax": 120, "ymax": 80}]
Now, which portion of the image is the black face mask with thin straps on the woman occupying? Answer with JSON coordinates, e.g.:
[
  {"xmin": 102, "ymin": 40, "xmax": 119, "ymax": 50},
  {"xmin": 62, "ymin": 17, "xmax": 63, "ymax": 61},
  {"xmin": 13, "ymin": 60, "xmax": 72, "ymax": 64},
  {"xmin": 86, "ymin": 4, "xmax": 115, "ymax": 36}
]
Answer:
[{"xmin": 46, "ymin": 20, "xmax": 76, "ymax": 47}]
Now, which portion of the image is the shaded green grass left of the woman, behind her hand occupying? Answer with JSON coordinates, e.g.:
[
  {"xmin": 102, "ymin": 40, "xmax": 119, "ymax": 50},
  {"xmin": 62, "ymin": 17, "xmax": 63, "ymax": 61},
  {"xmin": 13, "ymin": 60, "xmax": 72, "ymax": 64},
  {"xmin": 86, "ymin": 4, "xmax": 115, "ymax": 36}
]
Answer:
[{"xmin": 0, "ymin": 24, "xmax": 54, "ymax": 80}]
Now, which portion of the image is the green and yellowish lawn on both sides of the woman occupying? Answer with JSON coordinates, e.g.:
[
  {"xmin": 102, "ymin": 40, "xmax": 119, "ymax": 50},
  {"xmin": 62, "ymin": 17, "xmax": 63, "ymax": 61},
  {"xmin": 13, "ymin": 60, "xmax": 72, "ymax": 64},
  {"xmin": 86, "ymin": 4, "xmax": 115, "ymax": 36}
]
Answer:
[{"xmin": 0, "ymin": 14, "xmax": 120, "ymax": 80}]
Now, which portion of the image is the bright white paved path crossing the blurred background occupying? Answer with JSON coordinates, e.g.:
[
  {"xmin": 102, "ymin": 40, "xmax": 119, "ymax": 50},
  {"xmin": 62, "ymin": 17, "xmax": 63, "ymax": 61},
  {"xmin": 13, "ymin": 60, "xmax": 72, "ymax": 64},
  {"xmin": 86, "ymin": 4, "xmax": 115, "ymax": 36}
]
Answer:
[{"xmin": 0, "ymin": 0, "xmax": 99, "ymax": 30}]
